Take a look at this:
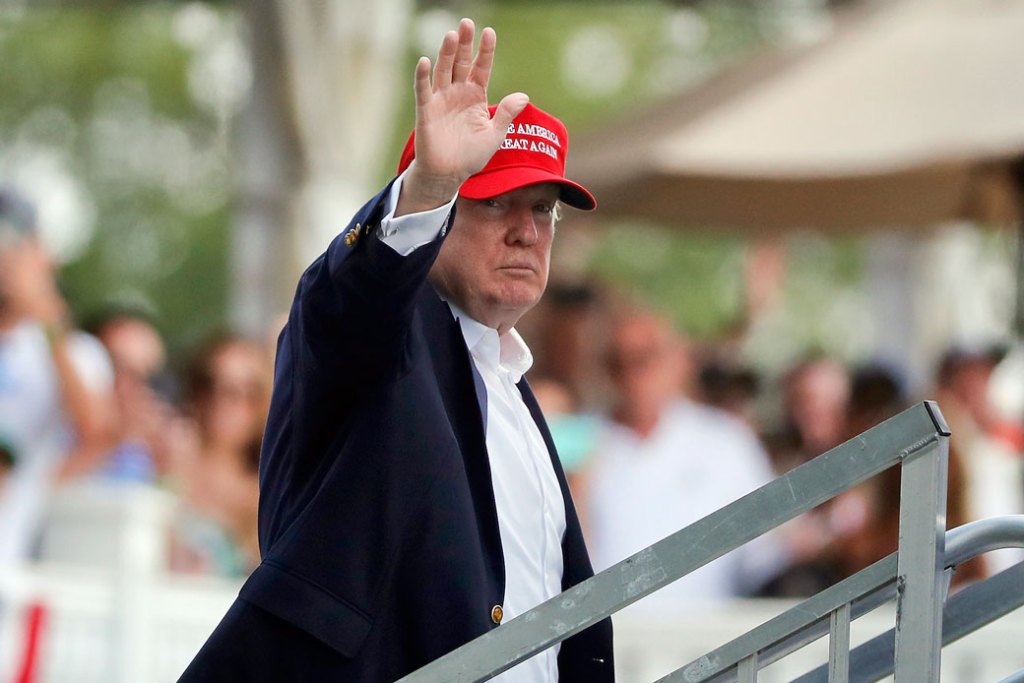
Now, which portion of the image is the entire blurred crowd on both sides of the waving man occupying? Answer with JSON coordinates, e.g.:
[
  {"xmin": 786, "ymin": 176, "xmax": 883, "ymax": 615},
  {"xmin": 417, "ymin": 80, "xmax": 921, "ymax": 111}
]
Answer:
[{"xmin": 0, "ymin": 185, "xmax": 1024, "ymax": 602}]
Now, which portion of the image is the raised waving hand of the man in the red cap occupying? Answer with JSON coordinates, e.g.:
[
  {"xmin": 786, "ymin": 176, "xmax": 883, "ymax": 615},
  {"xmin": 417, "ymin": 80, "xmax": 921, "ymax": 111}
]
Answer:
[{"xmin": 395, "ymin": 18, "xmax": 529, "ymax": 215}]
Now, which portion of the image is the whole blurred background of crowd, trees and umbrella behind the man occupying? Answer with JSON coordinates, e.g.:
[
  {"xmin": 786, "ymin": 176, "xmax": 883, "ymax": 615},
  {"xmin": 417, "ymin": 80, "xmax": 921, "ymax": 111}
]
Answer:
[{"xmin": 0, "ymin": 0, "xmax": 1024, "ymax": 682}]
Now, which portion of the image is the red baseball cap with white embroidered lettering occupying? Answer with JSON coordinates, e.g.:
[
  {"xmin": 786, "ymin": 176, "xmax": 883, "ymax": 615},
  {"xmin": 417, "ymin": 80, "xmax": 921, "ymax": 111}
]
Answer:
[{"xmin": 398, "ymin": 103, "xmax": 597, "ymax": 211}]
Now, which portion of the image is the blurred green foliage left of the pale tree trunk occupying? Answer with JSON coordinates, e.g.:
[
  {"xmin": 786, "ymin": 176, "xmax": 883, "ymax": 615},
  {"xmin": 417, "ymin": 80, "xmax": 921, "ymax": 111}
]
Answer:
[{"xmin": 0, "ymin": 4, "xmax": 229, "ymax": 356}]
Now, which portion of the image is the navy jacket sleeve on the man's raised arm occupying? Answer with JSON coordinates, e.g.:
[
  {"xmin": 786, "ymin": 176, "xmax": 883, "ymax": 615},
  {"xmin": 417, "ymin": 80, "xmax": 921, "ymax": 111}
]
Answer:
[{"xmin": 254, "ymin": 184, "xmax": 455, "ymax": 554}]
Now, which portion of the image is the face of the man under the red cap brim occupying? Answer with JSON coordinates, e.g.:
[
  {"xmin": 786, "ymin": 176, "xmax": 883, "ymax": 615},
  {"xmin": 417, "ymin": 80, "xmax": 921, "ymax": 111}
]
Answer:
[{"xmin": 430, "ymin": 182, "xmax": 558, "ymax": 332}]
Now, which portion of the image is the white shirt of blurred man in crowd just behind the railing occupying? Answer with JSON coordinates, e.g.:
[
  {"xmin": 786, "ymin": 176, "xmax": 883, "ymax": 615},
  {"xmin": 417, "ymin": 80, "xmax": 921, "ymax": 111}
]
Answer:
[{"xmin": 587, "ymin": 399, "xmax": 783, "ymax": 616}]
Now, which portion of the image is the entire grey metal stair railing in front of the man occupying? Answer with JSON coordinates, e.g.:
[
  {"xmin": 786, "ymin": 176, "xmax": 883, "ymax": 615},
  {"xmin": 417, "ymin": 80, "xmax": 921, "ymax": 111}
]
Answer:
[{"xmin": 400, "ymin": 401, "xmax": 1024, "ymax": 683}]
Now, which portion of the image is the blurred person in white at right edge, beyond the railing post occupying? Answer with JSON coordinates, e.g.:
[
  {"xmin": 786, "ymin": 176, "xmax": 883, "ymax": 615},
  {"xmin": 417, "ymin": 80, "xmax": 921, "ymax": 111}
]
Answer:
[{"xmin": 936, "ymin": 346, "xmax": 1024, "ymax": 570}]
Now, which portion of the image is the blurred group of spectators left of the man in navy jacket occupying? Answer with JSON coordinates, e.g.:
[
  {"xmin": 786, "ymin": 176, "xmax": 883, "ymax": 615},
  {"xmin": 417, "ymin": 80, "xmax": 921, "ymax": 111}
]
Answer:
[{"xmin": 0, "ymin": 191, "xmax": 272, "ymax": 577}]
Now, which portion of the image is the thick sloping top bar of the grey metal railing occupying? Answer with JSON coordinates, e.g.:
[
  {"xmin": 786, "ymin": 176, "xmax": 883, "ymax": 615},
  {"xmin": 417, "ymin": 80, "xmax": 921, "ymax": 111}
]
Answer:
[{"xmin": 401, "ymin": 403, "xmax": 941, "ymax": 683}]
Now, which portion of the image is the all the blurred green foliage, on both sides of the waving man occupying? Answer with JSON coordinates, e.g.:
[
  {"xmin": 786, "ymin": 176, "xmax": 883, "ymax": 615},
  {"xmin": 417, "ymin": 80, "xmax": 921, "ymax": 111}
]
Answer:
[{"xmin": 0, "ymin": 0, "xmax": 851, "ymax": 360}]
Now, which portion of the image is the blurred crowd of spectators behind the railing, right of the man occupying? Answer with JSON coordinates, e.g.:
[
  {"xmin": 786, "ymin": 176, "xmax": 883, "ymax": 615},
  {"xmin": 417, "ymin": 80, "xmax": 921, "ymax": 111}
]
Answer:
[{"xmin": 520, "ymin": 280, "xmax": 1024, "ymax": 615}]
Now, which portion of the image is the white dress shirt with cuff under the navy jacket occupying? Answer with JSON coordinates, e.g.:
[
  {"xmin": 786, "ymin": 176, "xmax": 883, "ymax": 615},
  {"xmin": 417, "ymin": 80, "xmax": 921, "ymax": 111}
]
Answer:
[{"xmin": 379, "ymin": 176, "xmax": 565, "ymax": 683}]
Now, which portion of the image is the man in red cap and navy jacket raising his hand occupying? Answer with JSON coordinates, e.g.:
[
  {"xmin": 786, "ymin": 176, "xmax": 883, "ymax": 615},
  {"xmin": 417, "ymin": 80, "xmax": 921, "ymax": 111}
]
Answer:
[{"xmin": 183, "ymin": 19, "xmax": 612, "ymax": 681}]
